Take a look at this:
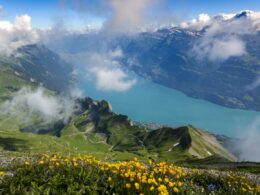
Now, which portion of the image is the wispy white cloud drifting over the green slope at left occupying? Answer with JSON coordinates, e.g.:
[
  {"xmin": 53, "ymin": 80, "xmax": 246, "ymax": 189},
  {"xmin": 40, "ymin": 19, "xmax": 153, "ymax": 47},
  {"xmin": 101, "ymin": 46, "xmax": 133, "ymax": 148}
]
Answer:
[{"xmin": 0, "ymin": 88, "xmax": 74, "ymax": 123}]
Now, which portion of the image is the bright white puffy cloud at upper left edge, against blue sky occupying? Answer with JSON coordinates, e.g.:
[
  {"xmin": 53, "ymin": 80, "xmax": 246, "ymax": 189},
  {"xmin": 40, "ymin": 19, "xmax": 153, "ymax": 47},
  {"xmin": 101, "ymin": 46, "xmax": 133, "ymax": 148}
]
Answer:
[{"xmin": 0, "ymin": 14, "xmax": 39, "ymax": 55}]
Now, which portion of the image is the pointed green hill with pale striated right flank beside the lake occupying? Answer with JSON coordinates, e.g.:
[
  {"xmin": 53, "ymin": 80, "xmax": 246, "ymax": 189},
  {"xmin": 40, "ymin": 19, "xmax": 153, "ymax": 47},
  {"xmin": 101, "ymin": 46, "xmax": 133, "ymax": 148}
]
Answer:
[{"xmin": 145, "ymin": 126, "xmax": 236, "ymax": 161}]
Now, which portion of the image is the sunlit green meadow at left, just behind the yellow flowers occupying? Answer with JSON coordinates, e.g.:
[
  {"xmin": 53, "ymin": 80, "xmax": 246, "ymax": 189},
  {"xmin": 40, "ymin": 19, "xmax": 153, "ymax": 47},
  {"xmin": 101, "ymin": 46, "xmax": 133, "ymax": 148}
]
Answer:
[{"xmin": 0, "ymin": 118, "xmax": 148, "ymax": 160}]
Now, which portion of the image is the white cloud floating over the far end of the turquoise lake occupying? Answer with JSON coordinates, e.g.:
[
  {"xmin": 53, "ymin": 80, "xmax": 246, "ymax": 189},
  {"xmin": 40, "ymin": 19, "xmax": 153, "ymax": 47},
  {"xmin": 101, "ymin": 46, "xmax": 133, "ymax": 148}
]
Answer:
[{"xmin": 60, "ymin": 46, "xmax": 137, "ymax": 92}]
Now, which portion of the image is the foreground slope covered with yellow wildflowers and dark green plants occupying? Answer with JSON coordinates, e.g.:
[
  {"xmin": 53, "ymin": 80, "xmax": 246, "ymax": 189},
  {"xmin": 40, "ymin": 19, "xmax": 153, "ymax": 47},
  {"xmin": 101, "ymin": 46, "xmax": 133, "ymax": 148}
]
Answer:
[{"xmin": 0, "ymin": 154, "xmax": 260, "ymax": 195}]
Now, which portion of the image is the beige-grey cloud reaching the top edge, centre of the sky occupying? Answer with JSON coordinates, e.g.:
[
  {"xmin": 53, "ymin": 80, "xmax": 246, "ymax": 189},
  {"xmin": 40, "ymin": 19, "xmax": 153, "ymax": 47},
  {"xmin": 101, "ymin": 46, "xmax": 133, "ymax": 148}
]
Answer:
[{"xmin": 60, "ymin": 0, "xmax": 160, "ymax": 35}]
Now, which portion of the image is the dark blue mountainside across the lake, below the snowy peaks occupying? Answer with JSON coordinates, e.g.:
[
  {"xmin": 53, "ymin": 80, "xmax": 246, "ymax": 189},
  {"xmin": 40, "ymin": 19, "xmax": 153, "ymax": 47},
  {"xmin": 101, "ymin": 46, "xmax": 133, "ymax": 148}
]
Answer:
[{"xmin": 117, "ymin": 27, "xmax": 260, "ymax": 110}]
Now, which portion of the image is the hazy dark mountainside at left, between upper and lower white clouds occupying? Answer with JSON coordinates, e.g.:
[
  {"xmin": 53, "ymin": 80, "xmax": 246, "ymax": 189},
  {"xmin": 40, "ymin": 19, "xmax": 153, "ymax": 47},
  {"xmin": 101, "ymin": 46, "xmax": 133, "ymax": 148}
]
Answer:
[{"xmin": 0, "ymin": 44, "xmax": 72, "ymax": 96}]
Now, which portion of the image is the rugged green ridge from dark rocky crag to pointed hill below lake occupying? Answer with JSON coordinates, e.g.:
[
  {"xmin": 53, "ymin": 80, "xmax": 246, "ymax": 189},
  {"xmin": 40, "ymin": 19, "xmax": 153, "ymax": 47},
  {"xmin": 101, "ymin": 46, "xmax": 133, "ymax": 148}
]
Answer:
[{"xmin": 58, "ymin": 99, "xmax": 236, "ymax": 161}]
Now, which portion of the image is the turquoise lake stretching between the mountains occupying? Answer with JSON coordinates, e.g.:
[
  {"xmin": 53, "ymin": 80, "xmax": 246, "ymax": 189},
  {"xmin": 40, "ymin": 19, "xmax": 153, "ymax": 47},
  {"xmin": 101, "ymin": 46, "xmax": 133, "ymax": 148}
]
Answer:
[{"xmin": 80, "ymin": 77, "xmax": 260, "ymax": 137}]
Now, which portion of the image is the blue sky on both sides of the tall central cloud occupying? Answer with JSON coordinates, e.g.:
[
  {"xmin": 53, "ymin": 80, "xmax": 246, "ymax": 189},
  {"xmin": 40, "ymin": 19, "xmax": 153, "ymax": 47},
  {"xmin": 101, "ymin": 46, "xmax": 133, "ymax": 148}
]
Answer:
[{"xmin": 0, "ymin": 0, "xmax": 260, "ymax": 28}]
